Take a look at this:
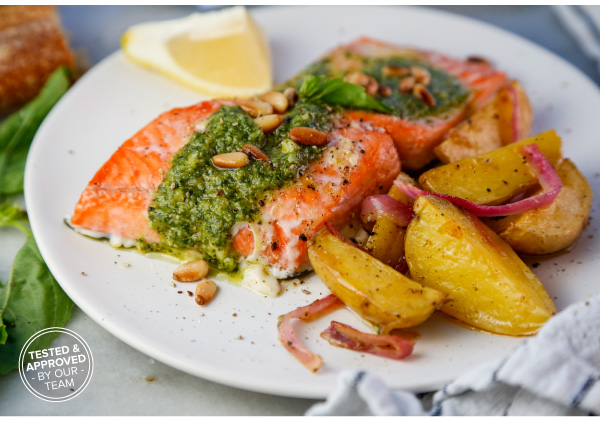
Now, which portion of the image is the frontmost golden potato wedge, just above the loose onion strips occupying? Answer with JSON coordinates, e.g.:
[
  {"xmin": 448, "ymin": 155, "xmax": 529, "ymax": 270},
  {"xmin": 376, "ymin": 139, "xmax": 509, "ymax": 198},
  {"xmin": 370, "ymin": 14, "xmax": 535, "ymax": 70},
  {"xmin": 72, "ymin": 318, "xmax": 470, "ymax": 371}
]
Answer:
[{"xmin": 308, "ymin": 230, "xmax": 446, "ymax": 334}]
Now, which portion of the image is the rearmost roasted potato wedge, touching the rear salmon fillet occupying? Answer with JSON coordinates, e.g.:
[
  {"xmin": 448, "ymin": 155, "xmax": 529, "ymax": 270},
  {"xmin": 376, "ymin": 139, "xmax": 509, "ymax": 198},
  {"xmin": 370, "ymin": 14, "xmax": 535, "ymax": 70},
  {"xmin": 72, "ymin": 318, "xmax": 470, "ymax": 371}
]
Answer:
[{"xmin": 434, "ymin": 81, "xmax": 533, "ymax": 163}]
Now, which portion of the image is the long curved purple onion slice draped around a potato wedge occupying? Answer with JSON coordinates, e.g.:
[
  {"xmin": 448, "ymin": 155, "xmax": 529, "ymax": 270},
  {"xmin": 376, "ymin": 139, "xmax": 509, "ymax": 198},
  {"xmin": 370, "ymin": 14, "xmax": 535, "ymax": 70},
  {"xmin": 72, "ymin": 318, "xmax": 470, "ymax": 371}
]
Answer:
[{"xmin": 394, "ymin": 144, "xmax": 562, "ymax": 217}]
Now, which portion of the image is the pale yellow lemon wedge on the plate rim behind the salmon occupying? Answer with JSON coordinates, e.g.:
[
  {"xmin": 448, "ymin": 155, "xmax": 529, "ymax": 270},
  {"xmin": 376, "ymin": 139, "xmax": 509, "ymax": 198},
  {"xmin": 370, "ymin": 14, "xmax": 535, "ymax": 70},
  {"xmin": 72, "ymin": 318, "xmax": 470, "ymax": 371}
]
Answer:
[{"xmin": 121, "ymin": 6, "xmax": 272, "ymax": 97}]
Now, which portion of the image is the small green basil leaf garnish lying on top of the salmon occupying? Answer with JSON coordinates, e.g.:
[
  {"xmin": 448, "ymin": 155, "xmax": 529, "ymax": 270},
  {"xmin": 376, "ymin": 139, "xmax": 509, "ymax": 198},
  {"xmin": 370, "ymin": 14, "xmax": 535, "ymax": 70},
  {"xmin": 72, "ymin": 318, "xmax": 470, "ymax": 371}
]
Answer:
[{"xmin": 298, "ymin": 76, "xmax": 394, "ymax": 113}]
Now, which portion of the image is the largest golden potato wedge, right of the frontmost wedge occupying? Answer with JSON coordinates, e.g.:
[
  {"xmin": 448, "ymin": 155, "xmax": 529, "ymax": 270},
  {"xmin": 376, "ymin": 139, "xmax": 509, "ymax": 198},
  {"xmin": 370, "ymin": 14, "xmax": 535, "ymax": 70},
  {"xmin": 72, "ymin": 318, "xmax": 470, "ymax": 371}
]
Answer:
[{"xmin": 405, "ymin": 196, "xmax": 556, "ymax": 336}]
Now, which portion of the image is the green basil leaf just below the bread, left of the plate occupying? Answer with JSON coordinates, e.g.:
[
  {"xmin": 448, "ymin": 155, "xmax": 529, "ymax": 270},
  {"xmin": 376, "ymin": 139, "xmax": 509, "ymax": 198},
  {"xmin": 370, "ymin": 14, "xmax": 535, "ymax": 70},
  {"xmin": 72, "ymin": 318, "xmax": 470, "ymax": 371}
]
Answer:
[{"xmin": 0, "ymin": 67, "xmax": 70, "ymax": 195}]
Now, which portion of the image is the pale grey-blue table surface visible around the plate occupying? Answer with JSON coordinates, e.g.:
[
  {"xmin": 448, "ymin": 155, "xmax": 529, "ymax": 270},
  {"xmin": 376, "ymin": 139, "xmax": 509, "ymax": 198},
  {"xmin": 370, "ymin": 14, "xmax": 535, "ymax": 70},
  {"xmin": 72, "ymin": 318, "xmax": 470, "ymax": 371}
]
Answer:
[{"xmin": 0, "ymin": 6, "xmax": 599, "ymax": 415}]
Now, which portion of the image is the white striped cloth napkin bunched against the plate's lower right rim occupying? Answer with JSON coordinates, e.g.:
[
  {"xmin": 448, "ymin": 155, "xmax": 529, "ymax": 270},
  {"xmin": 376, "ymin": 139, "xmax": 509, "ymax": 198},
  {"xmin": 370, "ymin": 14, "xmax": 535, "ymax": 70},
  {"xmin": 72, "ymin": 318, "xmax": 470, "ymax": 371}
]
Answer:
[{"xmin": 306, "ymin": 296, "xmax": 600, "ymax": 416}]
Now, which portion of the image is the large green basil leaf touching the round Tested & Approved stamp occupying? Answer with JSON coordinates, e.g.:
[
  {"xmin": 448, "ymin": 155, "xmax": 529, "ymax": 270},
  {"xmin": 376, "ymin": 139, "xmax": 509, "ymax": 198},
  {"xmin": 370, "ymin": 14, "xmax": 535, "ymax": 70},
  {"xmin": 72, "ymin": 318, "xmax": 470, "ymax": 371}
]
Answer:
[{"xmin": 0, "ymin": 234, "xmax": 73, "ymax": 374}]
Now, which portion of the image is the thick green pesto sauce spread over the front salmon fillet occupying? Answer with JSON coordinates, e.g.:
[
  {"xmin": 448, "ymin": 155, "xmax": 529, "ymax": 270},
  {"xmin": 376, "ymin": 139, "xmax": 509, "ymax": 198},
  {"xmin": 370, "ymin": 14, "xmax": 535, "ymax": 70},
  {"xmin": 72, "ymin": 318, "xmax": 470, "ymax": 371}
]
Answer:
[{"xmin": 146, "ymin": 101, "xmax": 333, "ymax": 271}]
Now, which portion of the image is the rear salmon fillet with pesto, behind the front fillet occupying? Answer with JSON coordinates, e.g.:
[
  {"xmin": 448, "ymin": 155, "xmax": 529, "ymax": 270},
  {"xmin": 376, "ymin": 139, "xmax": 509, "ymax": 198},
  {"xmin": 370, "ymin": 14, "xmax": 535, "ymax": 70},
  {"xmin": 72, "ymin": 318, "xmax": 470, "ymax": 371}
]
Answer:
[{"xmin": 285, "ymin": 37, "xmax": 507, "ymax": 171}]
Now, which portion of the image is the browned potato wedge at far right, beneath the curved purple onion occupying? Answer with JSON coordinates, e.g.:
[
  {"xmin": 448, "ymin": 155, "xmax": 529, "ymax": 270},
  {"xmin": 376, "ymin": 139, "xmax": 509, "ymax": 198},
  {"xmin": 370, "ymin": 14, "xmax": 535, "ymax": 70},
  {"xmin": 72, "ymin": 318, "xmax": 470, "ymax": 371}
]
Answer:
[{"xmin": 486, "ymin": 159, "xmax": 592, "ymax": 254}]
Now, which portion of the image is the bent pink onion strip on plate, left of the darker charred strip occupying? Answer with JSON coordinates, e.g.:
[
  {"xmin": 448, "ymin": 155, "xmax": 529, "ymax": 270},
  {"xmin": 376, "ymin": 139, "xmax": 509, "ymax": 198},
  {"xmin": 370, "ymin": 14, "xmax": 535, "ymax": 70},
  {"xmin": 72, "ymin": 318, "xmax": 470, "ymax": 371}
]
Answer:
[{"xmin": 277, "ymin": 294, "xmax": 344, "ymax": 373}]
